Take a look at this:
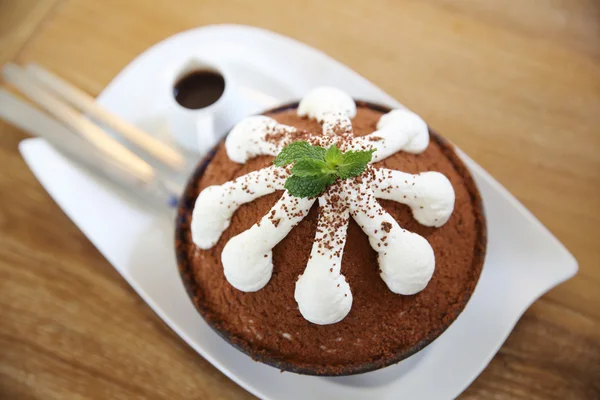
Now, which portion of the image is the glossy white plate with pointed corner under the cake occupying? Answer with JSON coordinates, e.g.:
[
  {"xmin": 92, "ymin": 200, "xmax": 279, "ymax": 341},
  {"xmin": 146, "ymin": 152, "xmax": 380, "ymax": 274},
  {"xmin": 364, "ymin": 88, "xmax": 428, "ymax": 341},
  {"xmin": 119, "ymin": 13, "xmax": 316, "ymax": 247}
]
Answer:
[{"xmin": 20, "ymin": 25, "xmax": 577, "ymax": 399}]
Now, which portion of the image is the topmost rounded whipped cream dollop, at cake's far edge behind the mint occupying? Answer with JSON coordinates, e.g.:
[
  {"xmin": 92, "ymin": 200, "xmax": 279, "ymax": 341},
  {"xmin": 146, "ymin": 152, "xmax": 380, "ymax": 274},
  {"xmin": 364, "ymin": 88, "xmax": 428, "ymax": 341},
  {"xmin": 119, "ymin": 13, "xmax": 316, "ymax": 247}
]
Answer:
[{"xmin": 298, "ymin": 87, "xmax": 356, "ymax": 121}]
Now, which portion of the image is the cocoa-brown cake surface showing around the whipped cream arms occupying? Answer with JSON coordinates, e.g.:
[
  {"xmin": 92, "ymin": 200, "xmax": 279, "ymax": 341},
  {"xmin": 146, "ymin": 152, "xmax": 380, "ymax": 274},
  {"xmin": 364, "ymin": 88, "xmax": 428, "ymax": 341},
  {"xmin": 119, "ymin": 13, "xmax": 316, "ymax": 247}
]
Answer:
[{"xmin": 176, "ymin": 100, "xmax": 483, "ymax": 374}]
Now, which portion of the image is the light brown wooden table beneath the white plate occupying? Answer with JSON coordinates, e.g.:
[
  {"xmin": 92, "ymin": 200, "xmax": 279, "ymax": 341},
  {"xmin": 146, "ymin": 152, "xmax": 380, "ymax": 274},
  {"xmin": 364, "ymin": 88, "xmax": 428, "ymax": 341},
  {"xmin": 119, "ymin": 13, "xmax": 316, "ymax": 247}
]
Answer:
[{"xmin": 0, "ymin": 0, "xmax": 600, "ymax": 399}]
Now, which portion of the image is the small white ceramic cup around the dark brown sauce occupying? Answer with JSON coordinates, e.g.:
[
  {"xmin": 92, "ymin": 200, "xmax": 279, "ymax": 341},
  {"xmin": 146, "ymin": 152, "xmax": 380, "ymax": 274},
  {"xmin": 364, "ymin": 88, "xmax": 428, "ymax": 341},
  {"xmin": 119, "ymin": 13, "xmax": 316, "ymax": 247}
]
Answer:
[{"xmin": 166, "ymin": 56, "xmax": 236, "ymax": 154}]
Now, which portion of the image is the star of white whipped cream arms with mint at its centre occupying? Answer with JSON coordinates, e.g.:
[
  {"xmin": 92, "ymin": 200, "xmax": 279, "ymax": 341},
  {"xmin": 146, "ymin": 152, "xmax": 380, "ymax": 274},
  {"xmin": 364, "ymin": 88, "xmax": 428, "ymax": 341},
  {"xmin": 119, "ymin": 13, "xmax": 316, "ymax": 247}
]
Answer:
[{"xmin": 191, "ymin": 88, "xmax": 455, "ymax": 325}]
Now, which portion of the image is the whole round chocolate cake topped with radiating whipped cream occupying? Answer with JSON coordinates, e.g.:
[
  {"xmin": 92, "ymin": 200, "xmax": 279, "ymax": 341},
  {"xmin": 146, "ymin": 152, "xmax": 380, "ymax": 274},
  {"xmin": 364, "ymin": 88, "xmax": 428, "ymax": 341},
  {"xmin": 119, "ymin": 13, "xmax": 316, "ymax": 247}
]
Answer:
[{"xmin": 176, "ymin": 89, "xmax": 486, "ymax": 375}]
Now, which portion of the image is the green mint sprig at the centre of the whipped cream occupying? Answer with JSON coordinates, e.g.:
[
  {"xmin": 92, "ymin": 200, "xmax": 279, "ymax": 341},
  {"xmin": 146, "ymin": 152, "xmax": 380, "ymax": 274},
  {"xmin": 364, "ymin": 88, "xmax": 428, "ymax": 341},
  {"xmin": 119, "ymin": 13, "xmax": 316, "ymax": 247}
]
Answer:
[{"xmin": 273, "ymin": 141, "xmax": 375, "ymax": 197}]
